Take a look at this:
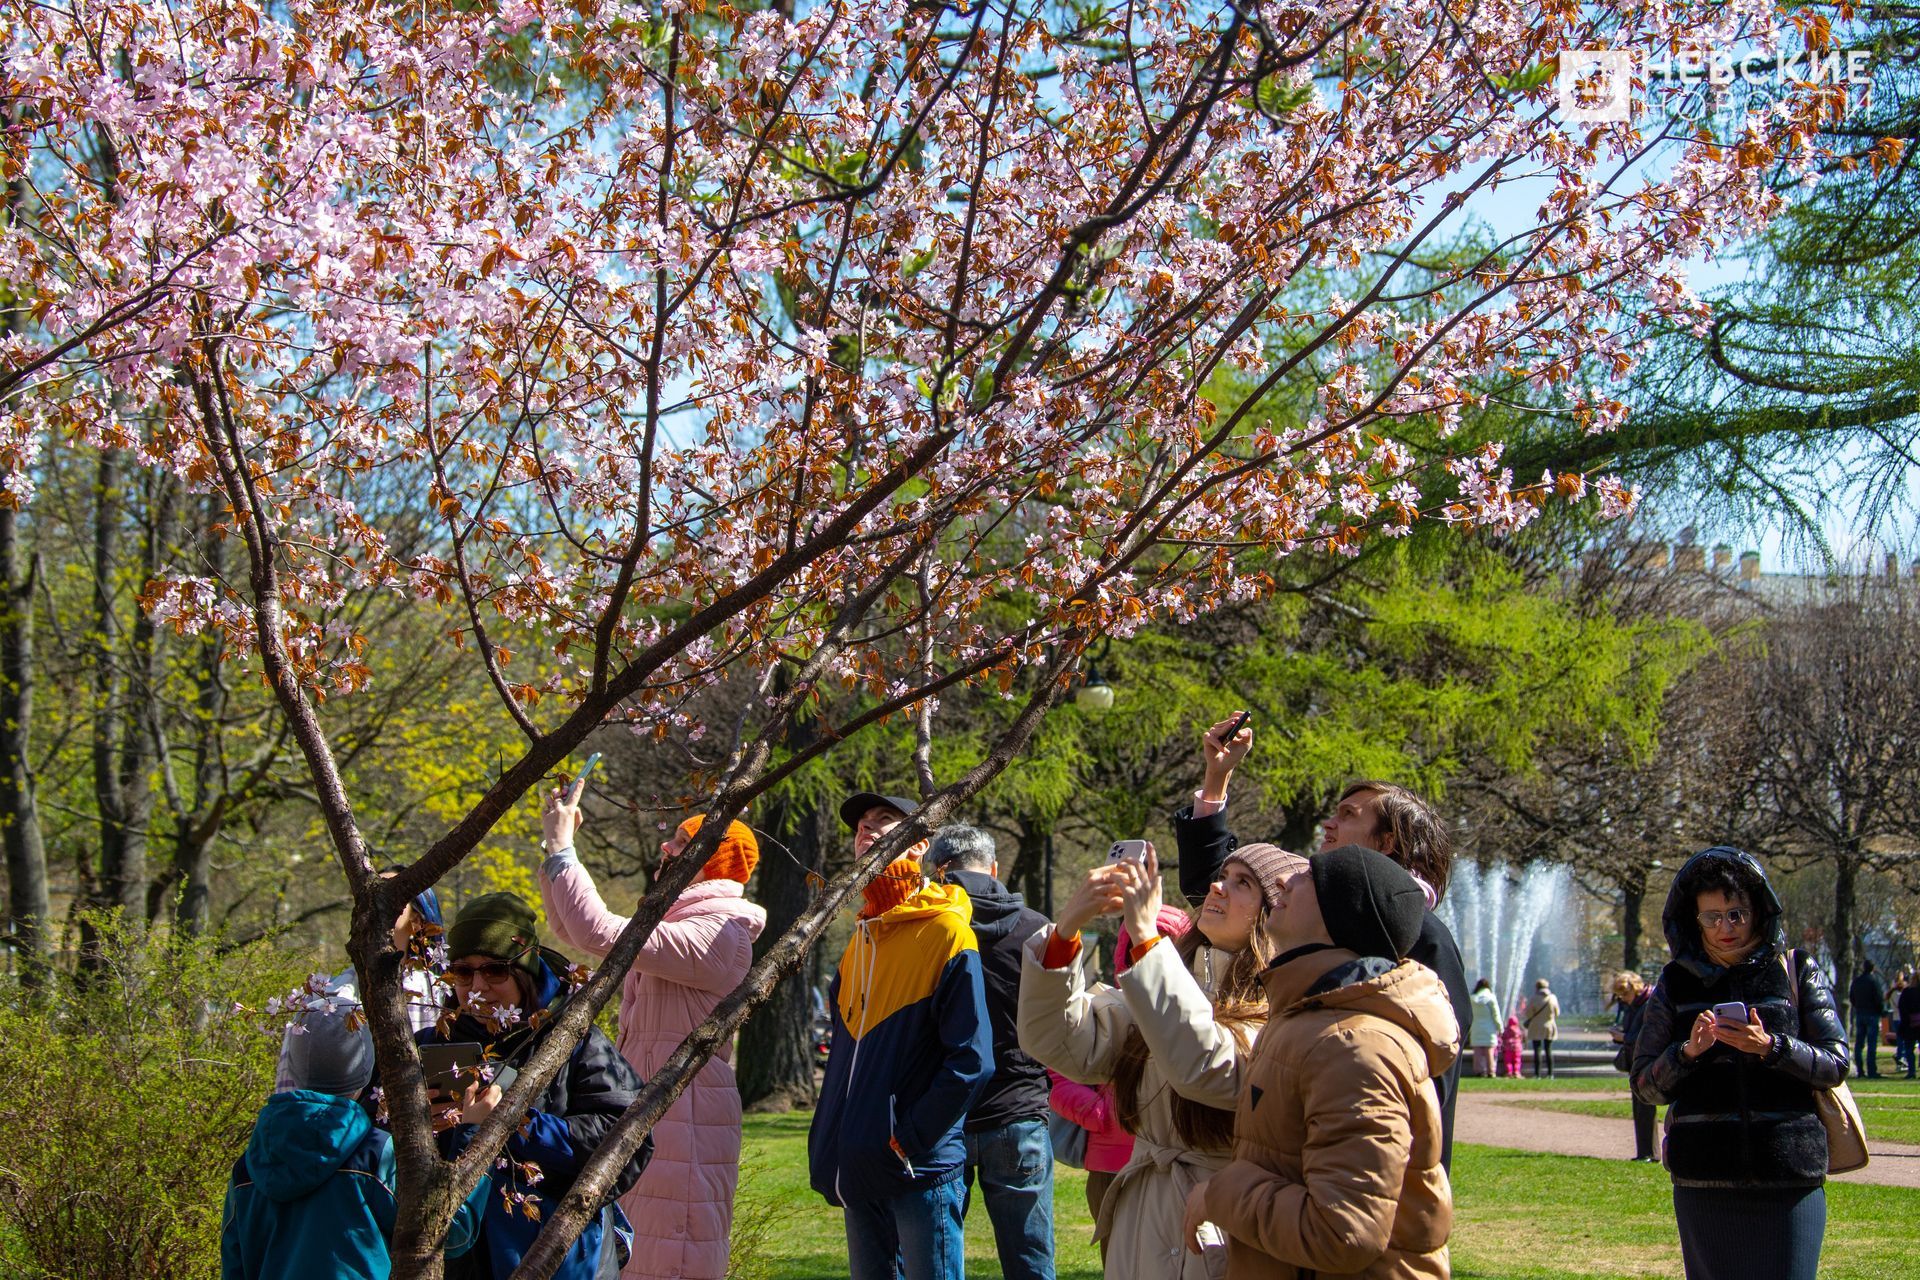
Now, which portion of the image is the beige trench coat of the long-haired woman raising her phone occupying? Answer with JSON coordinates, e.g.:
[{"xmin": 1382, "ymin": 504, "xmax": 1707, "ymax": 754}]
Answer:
[{"xmin": 1020, "ymin": 925, "xmax": 1260, "ymax": 1280}]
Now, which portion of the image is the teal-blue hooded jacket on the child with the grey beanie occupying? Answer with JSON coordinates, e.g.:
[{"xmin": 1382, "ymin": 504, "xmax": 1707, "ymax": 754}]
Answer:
[{"xmin": 221, "ymin": 1090, "xmax": 488, "ymax": 1280}]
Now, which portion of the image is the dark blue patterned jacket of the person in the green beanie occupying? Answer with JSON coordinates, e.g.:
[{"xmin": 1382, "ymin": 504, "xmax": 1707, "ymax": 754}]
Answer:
[{"xmin": 415, "ymin": 948, "xmax": 653, "ymax": 1280}]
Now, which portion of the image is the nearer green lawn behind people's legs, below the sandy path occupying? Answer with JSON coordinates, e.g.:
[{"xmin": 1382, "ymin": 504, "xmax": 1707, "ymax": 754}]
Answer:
[{"xmin": 733, "ymin": 1100, "xmax": 1920, "ymax": 1280}]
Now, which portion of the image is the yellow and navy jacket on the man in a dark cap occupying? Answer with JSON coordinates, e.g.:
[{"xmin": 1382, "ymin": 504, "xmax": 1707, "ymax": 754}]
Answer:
[{"xmin": 806, "ymin": 885, "xmax": 993, "ymax": 1205}]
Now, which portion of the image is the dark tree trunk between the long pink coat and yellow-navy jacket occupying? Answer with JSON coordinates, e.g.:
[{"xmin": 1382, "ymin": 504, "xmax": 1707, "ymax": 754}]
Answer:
[{"xmin": 737, "ymin": 790, "xmax": 828, "ymax": 1111}]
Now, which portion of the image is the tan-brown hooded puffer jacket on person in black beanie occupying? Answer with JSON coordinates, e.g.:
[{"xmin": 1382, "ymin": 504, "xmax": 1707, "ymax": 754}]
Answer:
[{"xmin": 1206, "ymin": 948, "xmax": 1459, "ymax": 1280}]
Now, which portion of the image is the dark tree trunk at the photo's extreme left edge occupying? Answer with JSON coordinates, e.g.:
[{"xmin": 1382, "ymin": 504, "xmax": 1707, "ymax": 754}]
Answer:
[{"xmin": 0, "ymin": 509, "xmax": 52, "ymax": 981}]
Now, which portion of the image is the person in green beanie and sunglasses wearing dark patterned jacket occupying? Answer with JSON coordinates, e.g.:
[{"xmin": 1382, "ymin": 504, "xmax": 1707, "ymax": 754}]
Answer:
[{"xmin": 415, "ymin": 892, "xmax": 653, "ymax": 1280}]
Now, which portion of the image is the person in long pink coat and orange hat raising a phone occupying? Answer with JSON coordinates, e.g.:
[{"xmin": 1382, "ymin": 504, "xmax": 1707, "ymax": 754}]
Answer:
[{"xmin": 540, "ymin": 791, "xmax": 766, "ymax": 1280}]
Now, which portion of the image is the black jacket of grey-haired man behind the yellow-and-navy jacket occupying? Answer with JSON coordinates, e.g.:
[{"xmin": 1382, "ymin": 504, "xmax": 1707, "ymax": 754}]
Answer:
[{"xmin": 947, "ymin": 871, "xmax": 1050, "ymax": 1134}]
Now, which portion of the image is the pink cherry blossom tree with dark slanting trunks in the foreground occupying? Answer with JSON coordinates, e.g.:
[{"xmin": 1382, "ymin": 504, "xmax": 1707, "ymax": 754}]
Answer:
[{"xmin": 0, "ymin": 0, "xmax": 1845, "ymax": 1276}]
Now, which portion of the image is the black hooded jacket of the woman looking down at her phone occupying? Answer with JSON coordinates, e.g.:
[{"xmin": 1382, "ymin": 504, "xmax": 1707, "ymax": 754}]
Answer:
[{"xmin": 1634, "ymin": 846, "xmax": 1847, "ymax": 1190}]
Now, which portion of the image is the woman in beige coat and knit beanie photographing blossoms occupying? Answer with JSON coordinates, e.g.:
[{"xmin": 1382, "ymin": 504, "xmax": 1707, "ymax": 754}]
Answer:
[{"xmin": 1020, "ymin": 844, "xmax": 1306, "ymax": 1280}]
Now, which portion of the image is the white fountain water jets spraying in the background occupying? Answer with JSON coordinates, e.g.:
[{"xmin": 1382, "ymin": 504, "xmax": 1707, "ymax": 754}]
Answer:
[{"xmin": 1434, "ymin": 858, "xmax": 1571, "ymax": 1021}]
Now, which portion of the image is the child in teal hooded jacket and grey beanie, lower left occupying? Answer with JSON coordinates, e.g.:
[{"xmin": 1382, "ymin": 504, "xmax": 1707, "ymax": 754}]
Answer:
[{"xmin": 221, "ymin": 996, "xmax": 492, "ymax": 1280}]
